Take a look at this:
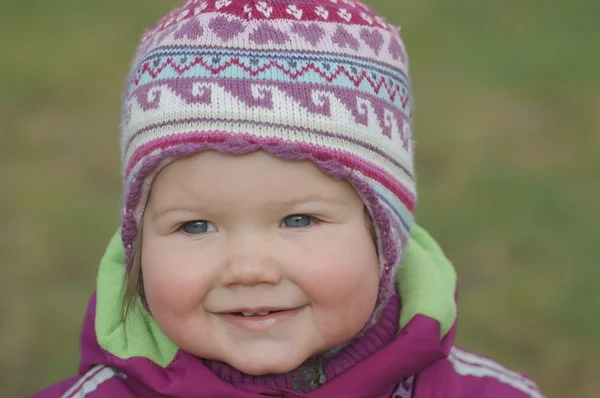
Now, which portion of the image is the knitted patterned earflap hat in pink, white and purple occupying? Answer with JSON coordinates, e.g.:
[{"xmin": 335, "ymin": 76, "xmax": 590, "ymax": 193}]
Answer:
[{"xmin": 121, "ymin": 0, "xmax": 416, "ymax": 309}]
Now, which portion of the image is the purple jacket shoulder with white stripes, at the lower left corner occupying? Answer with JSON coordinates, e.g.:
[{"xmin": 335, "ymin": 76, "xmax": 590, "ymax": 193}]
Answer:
[{"xmin": 31, "ymin": 365, "xmax": 136, "ymax": 398}]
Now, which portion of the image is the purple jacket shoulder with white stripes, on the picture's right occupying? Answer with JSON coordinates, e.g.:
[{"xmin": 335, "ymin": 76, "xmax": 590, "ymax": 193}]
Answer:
[{"xmin": 414, "ymin": 347, "xmax": 545, "ymax": 398}]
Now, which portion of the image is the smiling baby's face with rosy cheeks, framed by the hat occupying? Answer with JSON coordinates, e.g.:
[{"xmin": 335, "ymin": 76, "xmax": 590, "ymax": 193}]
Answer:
[{"xmin": 142, "ymin": 151, "xmax": 379, "ymax": 375}]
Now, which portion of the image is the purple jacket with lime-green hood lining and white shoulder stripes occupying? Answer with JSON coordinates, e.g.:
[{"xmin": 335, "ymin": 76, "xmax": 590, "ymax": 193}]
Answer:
[{"xmin": 33, "ymin": 227, "xmax": 543, "ymax": 398}]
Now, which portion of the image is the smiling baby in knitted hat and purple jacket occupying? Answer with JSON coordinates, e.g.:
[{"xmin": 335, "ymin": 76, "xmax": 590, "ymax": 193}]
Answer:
[{"xmin": 35, "ymin": 0, "xmax": 542, "ymax": 398}]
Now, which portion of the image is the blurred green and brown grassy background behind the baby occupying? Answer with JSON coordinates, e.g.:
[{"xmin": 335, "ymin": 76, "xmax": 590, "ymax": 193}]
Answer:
[{"xmin": 0, "ymin": 0, "xmax": 600, "ymax": 398}]
